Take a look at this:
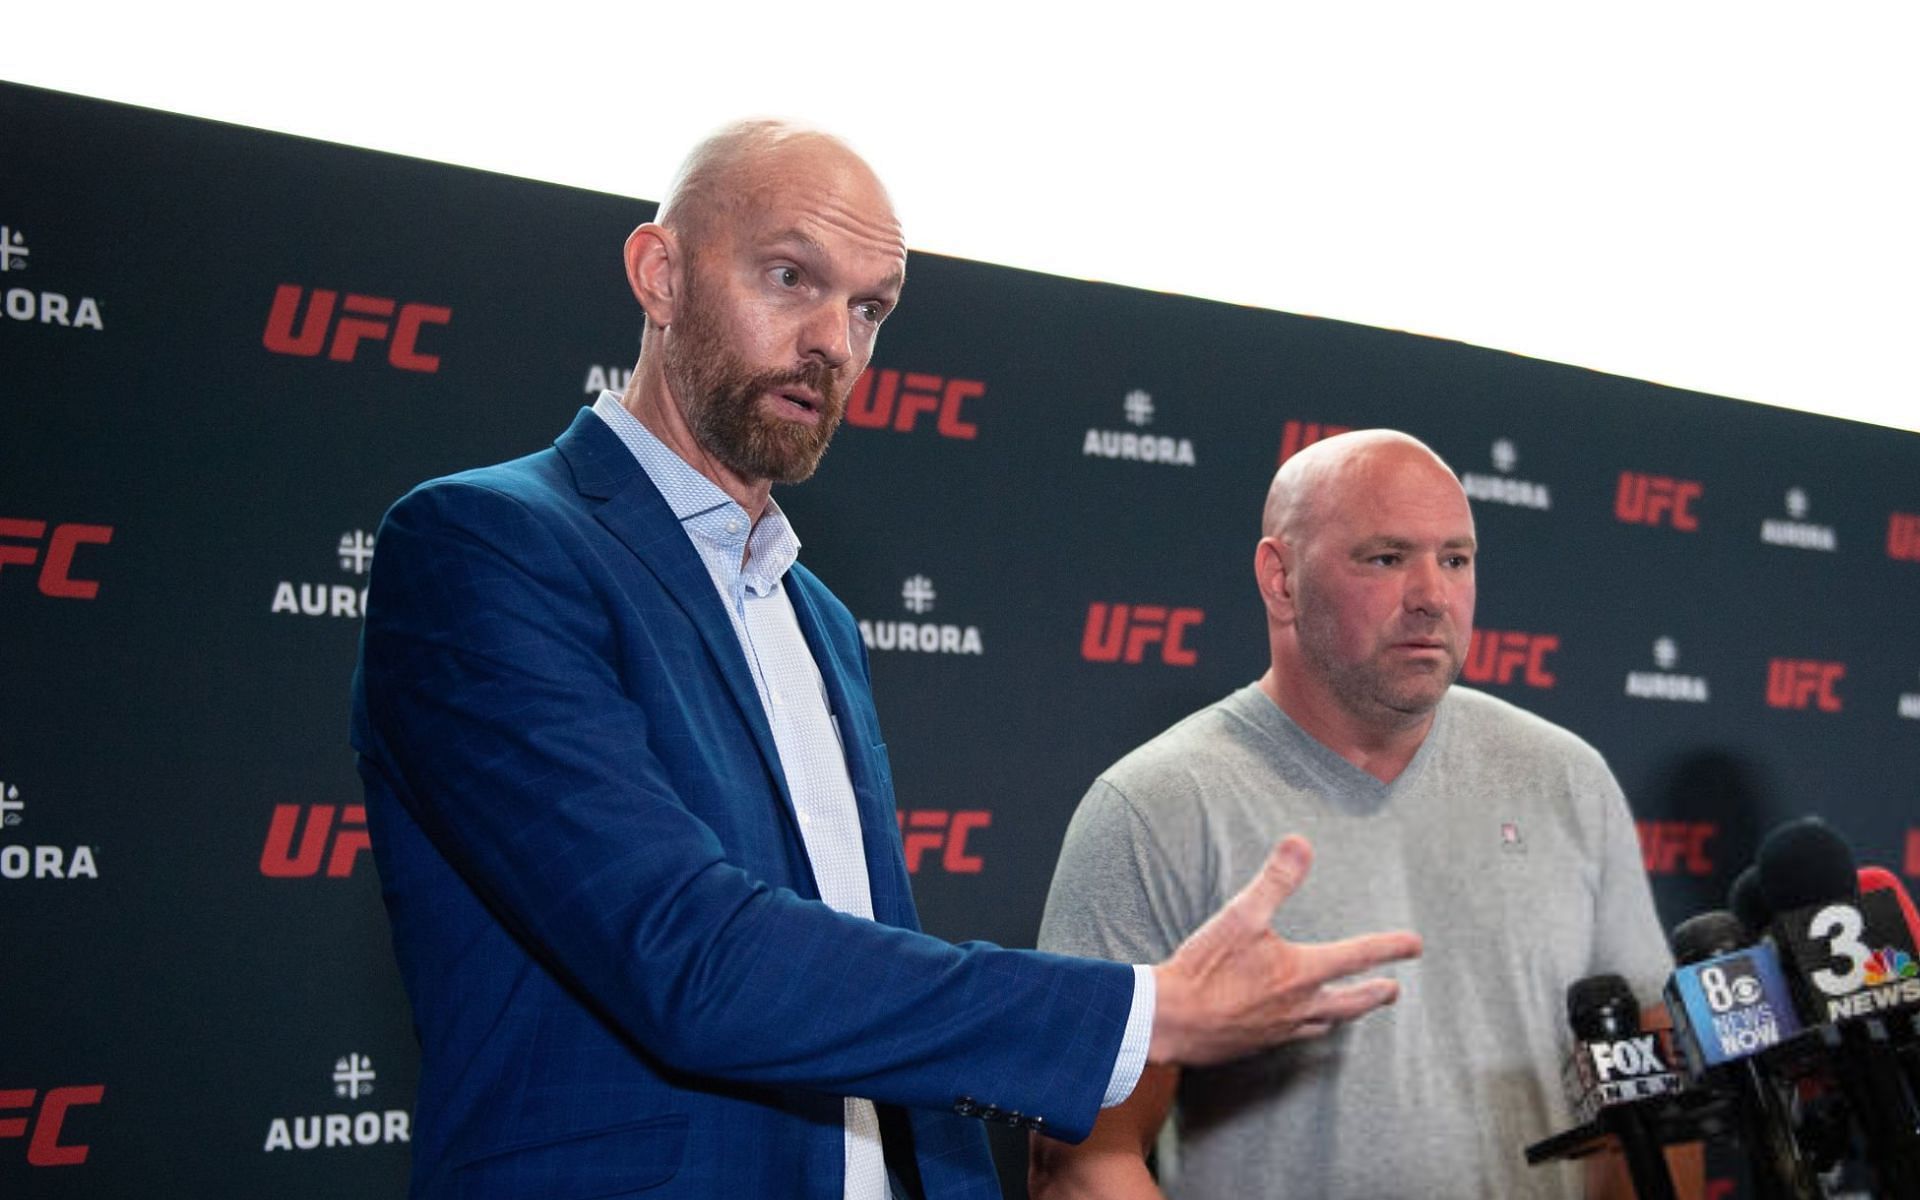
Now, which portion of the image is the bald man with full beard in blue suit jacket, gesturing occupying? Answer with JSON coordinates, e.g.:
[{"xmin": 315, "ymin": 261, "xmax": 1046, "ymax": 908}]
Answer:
[{"xmin": 353, "ymin": 114, "xmax": 1417, "ymax": 1200}]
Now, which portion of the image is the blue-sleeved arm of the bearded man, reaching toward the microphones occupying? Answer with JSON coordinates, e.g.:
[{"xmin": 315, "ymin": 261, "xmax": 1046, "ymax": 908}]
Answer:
[{"xmin": 355, "ymin": 484, "xmax": 1131, "ymax": 1137}]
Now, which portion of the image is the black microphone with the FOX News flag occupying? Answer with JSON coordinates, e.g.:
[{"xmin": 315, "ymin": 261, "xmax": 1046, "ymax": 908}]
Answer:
[{"xmin": 1567, "ymin": 975, "xmax": 1680, "ymax": 1200}]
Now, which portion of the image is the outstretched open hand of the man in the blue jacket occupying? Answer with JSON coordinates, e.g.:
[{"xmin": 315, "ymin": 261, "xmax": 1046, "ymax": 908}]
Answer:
[{"xmin": 1146, "ymin": 835, "xmax": 1421, "ymax": 1066}]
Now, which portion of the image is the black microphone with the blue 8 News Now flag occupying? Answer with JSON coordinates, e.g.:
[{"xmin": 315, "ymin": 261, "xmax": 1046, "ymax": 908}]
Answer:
[{"xmin": 1667, "ymin": 910, "xmax": 1824, "ymax": 1200}]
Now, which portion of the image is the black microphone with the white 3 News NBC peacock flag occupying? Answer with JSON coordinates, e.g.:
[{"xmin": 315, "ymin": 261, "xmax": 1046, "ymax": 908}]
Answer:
[{"xmin": 1757, "ymin": 818, "xmax": 1920, "ymax": 1200}]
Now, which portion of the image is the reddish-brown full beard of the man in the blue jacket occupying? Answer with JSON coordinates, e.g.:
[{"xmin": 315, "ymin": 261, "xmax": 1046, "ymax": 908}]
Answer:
[{"xmin": 662, "ymin": 269, "xmax": 847, "ymax": 484}]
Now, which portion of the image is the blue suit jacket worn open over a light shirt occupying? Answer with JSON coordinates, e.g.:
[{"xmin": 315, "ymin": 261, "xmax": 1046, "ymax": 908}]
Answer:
[{"xmin": 353, "ymin": 409, "xmax": 1133, "ymax": 1200}]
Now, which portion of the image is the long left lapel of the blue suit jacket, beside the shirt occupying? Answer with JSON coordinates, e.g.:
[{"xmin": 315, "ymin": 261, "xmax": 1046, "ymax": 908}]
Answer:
[{"xmin": 553, "ymin": 409, "xmax": 801, "ymax": 839}]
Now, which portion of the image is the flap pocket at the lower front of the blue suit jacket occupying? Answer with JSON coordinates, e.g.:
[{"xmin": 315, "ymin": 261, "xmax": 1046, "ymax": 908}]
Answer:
[{"xmin": 453, "ymin": 1116, "xmax": 687, "ymax": 1200}]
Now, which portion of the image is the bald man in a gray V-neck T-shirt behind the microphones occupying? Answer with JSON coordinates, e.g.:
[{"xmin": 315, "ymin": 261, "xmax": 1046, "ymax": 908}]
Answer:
[{"xmin": 1031, "ymin": 430, "xmax": 1672, "ymax": 1200}]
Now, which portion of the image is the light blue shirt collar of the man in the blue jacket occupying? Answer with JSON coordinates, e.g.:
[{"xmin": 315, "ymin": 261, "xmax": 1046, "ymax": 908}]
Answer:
[{"xmin": 593, "ymin": 392, "xmax": 801, "ymax": 595}]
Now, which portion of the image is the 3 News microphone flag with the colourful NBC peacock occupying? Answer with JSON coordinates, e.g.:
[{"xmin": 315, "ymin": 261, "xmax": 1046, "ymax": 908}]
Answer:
[{"xmin": 1786, "ymin": 891, "xmax": 1920, "ymax": 1021}]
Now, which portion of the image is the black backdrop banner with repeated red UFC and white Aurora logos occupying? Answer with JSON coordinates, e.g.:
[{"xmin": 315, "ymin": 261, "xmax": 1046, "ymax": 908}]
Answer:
[{"xmin": 0, "ymin": 84, "xmax": 1920, "ymax": 1198}]
